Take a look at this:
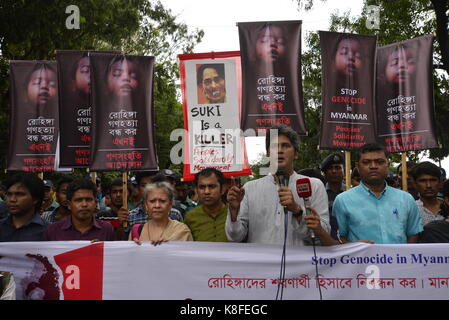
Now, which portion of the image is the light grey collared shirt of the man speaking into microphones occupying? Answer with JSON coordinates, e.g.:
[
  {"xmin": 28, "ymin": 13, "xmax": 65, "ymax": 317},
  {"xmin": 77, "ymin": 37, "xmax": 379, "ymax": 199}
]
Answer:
[{"xmin": 226, "ymin": 172, "xmax": 330, "ymax": 245}]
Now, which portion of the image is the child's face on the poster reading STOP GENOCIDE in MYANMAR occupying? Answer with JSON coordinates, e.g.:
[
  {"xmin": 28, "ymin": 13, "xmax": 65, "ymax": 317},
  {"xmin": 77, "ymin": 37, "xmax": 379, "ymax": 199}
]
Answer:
[{"xmin": 335, "ymin": 39, "xmax": 362, "ymax": 76}]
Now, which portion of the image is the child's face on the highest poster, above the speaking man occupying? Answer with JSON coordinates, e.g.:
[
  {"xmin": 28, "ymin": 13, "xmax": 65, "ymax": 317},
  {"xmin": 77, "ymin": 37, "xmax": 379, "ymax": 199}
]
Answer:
[{"xmin": 256, "ymin": 26, "xmax": 286, "ymax": 63}]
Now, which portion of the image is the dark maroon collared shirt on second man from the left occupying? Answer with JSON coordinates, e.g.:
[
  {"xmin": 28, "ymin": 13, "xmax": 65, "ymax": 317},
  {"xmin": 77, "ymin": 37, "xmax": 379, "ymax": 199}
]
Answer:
[{"xmin": 43, "ymin": 216, "xmax": 116, "ymax": 241}]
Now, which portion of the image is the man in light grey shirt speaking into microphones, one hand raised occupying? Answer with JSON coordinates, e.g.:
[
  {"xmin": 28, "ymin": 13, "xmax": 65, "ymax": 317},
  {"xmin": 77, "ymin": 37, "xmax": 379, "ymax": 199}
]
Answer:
[{"xmin": 226, "ymin": 125, "xmax": 338, "ymax": 245}]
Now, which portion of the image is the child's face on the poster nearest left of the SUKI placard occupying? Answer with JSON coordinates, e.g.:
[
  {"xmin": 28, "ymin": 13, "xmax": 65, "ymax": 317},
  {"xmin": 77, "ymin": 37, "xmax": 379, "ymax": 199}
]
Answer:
[{"xmin": 108, "ymin": 60, "xmax": 139, "ymax": 97}]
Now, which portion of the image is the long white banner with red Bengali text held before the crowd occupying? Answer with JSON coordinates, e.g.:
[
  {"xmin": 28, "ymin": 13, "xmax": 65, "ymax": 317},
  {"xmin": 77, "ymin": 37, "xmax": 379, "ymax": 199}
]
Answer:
[{"xmin": 0, "ymin": 241, "xmax": 449, "ymax": 300}]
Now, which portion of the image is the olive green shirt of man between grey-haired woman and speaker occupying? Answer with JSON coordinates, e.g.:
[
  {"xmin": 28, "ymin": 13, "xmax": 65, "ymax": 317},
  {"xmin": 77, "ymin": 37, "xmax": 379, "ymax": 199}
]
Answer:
[{"xmin": 184, "ymin": 205, "xmax": 228, "ymax": 242}]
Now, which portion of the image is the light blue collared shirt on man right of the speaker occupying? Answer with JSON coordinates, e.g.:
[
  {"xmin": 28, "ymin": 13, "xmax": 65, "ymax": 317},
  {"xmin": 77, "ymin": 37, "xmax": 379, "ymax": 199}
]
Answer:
[{"xmin": 332, "ymin": 183, "xmax": 423, "ymax": 244}]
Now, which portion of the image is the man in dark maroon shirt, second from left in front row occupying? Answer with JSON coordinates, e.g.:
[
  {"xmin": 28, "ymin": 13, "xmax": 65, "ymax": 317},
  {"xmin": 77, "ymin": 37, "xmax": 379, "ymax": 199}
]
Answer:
[{"xmin": 43, "ymin": 179, "xmax": 116, "ymax": 241}]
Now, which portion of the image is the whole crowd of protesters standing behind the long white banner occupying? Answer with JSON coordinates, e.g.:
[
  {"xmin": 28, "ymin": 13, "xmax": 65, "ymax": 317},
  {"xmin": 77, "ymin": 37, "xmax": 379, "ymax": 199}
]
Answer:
[{"xmin": 0, "ymin": 126, "xmax": 449, "ymax": 245}]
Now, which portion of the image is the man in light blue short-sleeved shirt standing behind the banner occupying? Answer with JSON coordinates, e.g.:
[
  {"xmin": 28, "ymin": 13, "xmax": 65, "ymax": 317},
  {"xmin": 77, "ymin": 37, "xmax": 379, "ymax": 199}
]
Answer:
[{"xmin": 333, "ymin": 144, "xmax": 423, "ymax": 244}]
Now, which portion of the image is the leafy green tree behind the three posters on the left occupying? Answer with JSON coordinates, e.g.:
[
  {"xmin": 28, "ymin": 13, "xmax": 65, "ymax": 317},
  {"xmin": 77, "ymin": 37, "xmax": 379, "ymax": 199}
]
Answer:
[{"xmin": 0, "ymin": 0, "xmax": 204, "ymax": 175}]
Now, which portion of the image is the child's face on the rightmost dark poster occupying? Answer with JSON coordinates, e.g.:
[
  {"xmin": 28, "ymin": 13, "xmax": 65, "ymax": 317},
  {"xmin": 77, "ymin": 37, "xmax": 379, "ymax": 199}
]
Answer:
[{"xmin": 385, "ymin": 48, "xmax": 416, "ymax": 84}]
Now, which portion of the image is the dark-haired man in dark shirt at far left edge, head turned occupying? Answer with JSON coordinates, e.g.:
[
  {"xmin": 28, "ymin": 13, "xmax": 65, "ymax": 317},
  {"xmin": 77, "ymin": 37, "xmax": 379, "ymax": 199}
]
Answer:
[{"xmin": 0, "ymin": 173, "xmax": 48, "ymax": 242}]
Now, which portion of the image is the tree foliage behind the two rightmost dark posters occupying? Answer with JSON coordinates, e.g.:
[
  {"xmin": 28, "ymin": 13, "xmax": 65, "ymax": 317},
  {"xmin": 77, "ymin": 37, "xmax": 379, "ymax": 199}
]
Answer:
[{"xmin": 297, "ymin": 0, "xmax": 449, "ymax": 168}]
